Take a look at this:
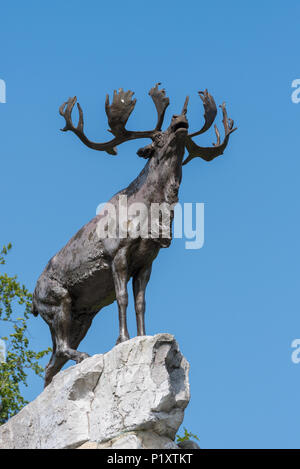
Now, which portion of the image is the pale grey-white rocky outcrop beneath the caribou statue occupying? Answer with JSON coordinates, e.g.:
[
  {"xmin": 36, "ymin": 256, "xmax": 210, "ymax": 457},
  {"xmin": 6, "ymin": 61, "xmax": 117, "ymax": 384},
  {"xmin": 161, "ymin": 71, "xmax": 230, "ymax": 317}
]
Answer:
[{"xmin": 0, "ymin": 334, "xmax": 190, "ymax": 449}]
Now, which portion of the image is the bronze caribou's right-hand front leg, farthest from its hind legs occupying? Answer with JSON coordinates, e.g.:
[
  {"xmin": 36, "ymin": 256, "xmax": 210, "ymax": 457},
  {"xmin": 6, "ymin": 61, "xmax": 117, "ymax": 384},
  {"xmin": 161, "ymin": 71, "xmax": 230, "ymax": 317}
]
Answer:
[{"xmin": 133, "ymin": 265, "xmax": 152, "ymax": 335}]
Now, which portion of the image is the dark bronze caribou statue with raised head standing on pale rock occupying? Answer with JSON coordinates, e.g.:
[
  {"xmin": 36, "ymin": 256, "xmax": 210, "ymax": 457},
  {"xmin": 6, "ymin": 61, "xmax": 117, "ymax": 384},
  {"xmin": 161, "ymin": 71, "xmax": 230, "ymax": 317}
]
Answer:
[{"xmin": 32, "ymin": 83, "xmax": 236, "ymax": 386}]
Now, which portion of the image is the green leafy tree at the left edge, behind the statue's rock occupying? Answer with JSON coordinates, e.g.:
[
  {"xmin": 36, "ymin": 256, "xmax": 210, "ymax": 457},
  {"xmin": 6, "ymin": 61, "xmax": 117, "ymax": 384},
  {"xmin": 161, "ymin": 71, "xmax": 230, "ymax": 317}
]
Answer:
[{"xmin": 0, "ymin": 244, "xmax": 51, "ymax": 425}]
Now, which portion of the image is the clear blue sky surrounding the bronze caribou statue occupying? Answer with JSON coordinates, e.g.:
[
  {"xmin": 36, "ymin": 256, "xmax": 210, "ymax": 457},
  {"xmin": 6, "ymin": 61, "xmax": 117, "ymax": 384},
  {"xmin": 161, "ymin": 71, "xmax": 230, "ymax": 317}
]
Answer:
[{"xmin": 0, "ymin": 0, "xmax": 300, "ymax": 448}]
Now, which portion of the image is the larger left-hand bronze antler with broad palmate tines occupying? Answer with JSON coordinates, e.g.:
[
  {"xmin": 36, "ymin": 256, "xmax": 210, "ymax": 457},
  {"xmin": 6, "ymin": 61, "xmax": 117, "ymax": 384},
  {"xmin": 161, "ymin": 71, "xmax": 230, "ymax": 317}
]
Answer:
[{"xmin": 59, "ymin": 83, "xmax": 169, "ymax": 155}]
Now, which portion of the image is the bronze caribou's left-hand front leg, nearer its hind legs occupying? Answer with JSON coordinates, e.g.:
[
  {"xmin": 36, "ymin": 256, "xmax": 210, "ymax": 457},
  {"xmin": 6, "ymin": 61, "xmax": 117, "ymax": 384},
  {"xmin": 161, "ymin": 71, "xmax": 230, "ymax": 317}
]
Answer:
[{"xmin": 112, "ymin": 248, "xmax": 129, "ymax": 344}]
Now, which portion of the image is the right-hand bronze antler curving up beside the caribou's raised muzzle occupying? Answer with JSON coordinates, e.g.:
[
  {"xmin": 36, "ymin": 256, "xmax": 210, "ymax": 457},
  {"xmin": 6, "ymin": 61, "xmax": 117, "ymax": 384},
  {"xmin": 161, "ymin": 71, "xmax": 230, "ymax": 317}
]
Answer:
[{"xmin": 182, "ymin": 95, "xmax": 237, "ymax": 165}]
